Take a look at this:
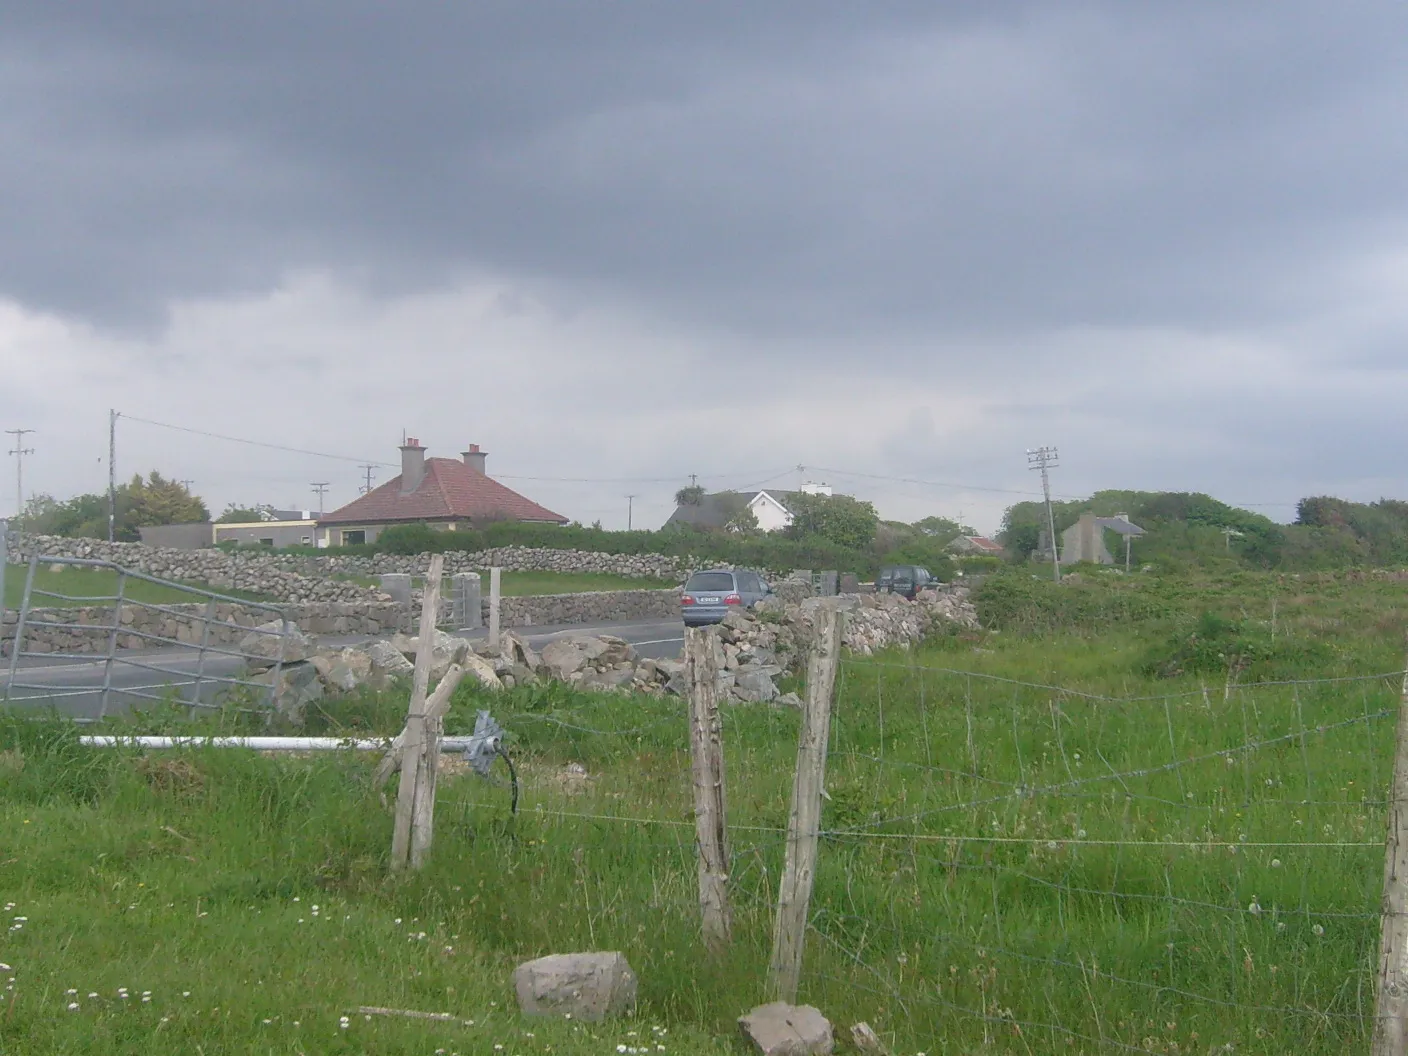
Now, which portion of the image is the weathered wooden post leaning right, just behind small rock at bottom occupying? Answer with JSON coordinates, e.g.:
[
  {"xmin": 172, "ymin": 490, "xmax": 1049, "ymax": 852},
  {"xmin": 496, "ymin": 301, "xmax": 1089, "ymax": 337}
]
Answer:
[{"xmin": 769, "ymin": 607, "xmax": 843, "ymax": 1004}]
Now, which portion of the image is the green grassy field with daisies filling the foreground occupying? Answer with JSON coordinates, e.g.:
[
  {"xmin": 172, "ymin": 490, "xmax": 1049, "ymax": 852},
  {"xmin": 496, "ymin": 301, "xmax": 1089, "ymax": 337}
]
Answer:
[{"xmin": 0, "ymin": 566, "xmax": 1404, "ymax": 1055}]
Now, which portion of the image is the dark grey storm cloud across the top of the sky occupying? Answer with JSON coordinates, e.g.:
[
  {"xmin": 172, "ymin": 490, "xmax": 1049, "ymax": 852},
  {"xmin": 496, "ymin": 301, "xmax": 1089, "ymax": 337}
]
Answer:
[{"xmin": 8, "ymin": 0, "xmax": 1408, "ymax": 335}]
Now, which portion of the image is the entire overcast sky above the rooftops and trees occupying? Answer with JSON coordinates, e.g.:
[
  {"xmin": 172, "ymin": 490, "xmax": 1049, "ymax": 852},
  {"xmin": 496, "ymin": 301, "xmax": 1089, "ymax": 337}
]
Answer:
[{"xmin": 0, "ymin": 0, "xmax": 1408, "ymax": 529}]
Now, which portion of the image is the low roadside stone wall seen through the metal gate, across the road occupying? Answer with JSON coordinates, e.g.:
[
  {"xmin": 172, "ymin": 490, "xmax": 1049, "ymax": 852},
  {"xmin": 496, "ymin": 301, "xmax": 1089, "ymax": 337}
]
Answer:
[{"xmin": 0, "ymin": 601, "xmax": 407, "ymax": 656}]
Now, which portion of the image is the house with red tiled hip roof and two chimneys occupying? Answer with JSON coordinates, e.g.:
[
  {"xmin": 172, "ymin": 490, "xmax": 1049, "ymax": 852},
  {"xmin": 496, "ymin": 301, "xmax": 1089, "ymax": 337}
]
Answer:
[{"xmin": 318, "ymin": 438, "xmax": 567, "ymax": 546}]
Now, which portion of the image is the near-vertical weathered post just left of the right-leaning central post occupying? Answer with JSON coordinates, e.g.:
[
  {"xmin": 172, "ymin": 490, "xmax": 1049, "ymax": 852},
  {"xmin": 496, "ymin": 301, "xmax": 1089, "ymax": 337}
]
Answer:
[{"xmin": 684, "ymin": 627, "xmax": 732, "ymax": 953}]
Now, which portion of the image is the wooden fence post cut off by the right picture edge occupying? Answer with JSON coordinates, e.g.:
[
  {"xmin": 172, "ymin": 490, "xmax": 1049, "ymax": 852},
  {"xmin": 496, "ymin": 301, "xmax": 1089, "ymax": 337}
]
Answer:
[{"xmin": 1370, "ymin": 653, "xmax": 1408, "ymax": 1056}]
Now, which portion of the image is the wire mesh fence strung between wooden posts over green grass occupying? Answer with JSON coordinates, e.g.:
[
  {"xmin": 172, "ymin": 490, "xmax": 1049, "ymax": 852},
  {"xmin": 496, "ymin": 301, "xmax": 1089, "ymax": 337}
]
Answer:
[{"xmin": 422, "ymin": 658, "xmax": 1404, "ymax": 1053}]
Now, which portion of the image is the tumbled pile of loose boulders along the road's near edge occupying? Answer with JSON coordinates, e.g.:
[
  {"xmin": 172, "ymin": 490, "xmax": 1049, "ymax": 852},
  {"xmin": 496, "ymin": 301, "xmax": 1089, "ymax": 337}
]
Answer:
[{"xmin": 242, "ymin": 587, "xmax": 977, "ymax": 722}]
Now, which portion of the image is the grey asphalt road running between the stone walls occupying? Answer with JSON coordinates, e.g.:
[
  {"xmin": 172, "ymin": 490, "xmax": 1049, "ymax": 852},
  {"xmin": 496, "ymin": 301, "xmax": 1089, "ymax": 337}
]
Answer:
[{"xmin": 0, "ymin": 620, "xmax": 684, "ymax": 721}]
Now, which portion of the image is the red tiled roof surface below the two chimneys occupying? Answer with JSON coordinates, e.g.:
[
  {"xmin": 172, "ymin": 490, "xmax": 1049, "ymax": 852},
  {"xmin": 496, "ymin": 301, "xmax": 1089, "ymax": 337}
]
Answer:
[{"xmin": 318, "ymin": 459, "xmax": 567, "ymax": 524}]
